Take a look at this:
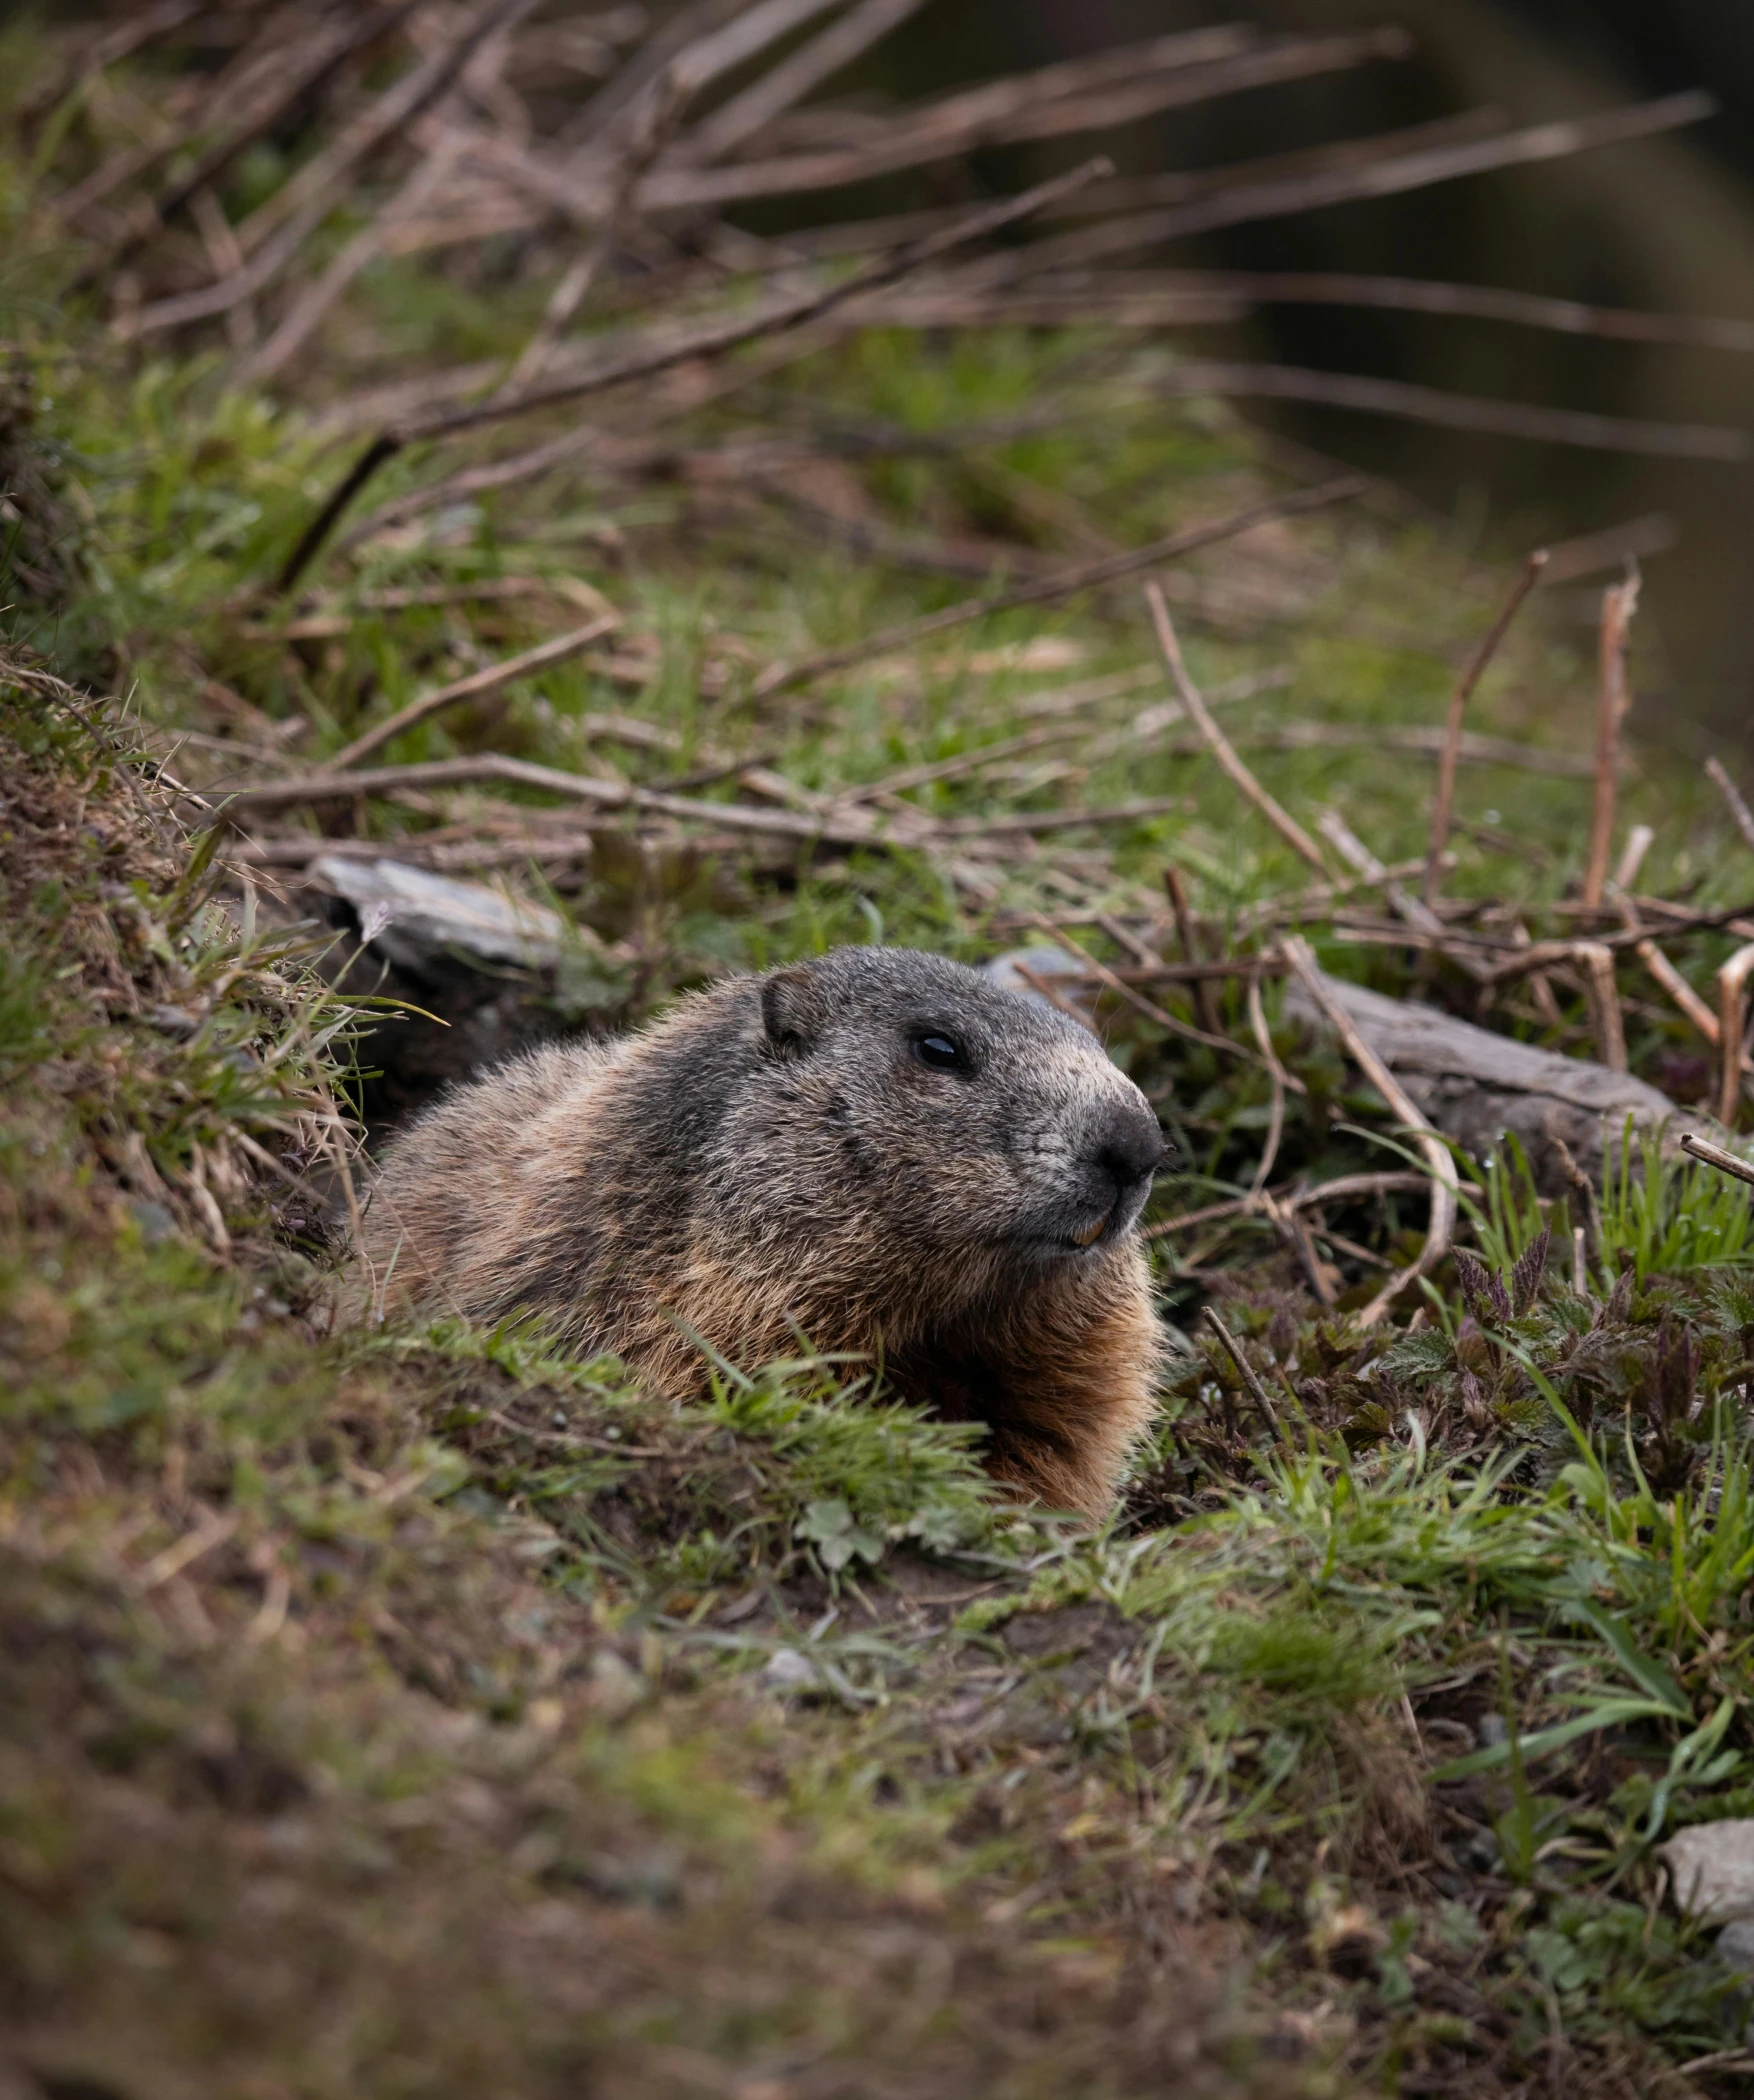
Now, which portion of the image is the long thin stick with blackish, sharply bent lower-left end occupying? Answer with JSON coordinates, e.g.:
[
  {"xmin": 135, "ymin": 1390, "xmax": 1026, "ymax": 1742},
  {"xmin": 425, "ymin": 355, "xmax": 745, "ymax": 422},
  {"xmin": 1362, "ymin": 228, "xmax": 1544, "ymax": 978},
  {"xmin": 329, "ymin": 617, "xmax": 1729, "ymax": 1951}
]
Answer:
[{"xmin": 275, "ymin": 160, "xmax": 1109, "ymax": 596}]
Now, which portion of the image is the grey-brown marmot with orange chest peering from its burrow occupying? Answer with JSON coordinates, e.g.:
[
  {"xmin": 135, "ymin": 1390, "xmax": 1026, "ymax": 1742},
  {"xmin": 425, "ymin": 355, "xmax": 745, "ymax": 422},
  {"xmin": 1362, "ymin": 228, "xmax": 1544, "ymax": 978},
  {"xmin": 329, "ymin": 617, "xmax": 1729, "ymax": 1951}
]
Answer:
[{"xmin": 366, "ymin": 947, "xmax": 1164, "ymax": 1516}]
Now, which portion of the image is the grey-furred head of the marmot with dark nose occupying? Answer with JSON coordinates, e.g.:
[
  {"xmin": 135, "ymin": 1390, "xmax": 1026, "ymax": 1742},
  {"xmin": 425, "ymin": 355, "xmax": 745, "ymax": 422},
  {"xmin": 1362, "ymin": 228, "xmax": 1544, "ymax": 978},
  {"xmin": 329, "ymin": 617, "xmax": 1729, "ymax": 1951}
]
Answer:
[{"xmin": 708, "ymin": 947, "xmax": 1166, "ymax": 1304}]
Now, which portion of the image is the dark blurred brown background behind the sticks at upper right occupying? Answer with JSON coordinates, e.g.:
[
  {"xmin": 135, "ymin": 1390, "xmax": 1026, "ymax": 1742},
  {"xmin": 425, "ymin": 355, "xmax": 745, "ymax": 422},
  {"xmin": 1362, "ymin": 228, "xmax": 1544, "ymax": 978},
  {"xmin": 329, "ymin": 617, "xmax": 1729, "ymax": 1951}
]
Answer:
[{"xmin": 831, "ymin": 0, "xmax": 1754, "ymax": 754}]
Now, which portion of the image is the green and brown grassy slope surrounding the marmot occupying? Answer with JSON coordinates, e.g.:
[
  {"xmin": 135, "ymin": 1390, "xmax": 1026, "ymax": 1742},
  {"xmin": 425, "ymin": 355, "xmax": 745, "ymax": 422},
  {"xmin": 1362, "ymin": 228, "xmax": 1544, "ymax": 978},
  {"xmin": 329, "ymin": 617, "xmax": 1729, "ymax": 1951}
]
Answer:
[{"xmin": 0, "ymin": 32, "xmax": 1754, "ymax": 2100}]
